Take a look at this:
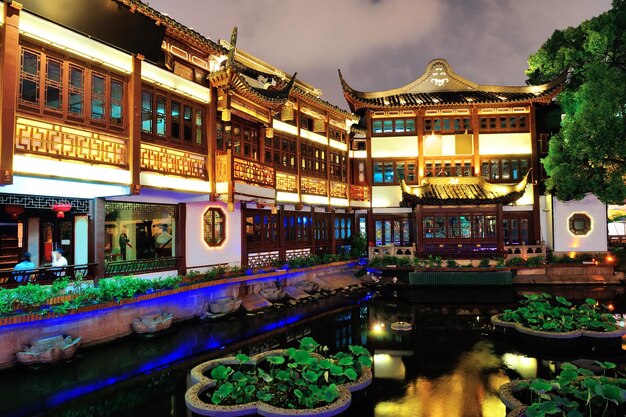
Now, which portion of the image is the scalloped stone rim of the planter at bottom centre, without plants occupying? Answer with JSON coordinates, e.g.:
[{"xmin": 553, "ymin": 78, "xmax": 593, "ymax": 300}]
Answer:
[{"xmin": 185, "ymin": 350, "xmax": 372, "ymax": 417}]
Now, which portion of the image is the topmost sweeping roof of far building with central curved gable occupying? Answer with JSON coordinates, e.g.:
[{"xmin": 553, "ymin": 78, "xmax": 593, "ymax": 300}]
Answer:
[{"xmin": 339, "ymin": 59, "xmax": 566, "ymax": 111}]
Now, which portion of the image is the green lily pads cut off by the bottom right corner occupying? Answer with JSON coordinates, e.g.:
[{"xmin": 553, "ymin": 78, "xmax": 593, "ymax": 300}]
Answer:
[{"xmin": 500, "ymin": 361, "xmax": 626, "ymax": 417}]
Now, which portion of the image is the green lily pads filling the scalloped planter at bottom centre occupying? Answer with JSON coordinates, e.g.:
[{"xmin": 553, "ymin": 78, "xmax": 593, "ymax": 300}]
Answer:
[{"xmin": 206, "ymin": 337, "xmax": 372, "ymax": 409}]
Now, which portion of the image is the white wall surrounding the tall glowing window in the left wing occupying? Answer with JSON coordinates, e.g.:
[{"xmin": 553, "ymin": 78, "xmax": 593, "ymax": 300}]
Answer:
[{"xmin": 185, "ymin": 202, "xmax": 241, "ymax": 269}]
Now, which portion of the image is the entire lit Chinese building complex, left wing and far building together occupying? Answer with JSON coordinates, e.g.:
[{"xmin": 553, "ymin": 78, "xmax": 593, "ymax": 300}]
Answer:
[{"xmin": 0, "ymin": 0, "xmax": 606, "ymax": 276}]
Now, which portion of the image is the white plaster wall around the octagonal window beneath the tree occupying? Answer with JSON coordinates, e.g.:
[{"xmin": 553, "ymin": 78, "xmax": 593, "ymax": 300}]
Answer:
[{"xmin": 552, "ymin": 194, "xmax": 607, "ymax": 252}]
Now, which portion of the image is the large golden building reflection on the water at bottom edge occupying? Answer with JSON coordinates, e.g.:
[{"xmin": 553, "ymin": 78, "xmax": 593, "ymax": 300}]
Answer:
[{"xmin": 374, "ymin": 342, "xmax": 509, "ymax": 417}]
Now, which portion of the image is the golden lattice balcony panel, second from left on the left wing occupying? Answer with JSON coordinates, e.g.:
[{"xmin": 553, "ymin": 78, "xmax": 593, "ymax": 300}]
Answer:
[{"xmin": 141, "ymin": 143, "xmax": 207, "ymax": 179}]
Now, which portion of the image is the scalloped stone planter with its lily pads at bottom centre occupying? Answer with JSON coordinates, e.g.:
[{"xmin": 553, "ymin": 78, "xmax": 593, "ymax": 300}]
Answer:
[{"xmin": 185, "ymin": 337, "xmax": 372, "ymax": 417}]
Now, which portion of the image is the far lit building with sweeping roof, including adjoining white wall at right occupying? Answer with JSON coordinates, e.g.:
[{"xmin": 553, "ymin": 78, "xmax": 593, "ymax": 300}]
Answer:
[{"xmin": 339, "ymin": 59, "xmax": 606, "ymax": 256}]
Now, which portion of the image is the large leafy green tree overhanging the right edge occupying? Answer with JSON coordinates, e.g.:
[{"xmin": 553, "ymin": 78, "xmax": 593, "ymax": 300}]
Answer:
[{"xmin": 526, "ymin": 0, "xmax": 626, "ymax": 204}]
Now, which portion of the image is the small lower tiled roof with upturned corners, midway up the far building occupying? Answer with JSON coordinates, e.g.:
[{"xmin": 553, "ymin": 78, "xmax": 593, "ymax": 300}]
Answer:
[{"xmin": 402, "ymin": 171, "xmax": 530, "ymax": 206}]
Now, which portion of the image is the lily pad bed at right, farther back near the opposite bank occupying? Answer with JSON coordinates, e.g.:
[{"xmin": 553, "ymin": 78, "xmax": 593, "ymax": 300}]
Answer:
[{"xmin": 499, "ymin": 293, "xmax": 618, "ymax": 333}]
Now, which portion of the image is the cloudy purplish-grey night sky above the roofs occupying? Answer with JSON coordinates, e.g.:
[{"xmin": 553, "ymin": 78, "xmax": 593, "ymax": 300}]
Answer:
[{"xmin": 144, "ymin": 0, "xmax": 611, "ymax": 108}]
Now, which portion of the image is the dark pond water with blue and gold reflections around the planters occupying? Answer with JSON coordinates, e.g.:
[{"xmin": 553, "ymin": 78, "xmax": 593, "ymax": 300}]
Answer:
[{"xmin": 0, "ymin": 287, "xmax": 626, "ymax": 417}]
